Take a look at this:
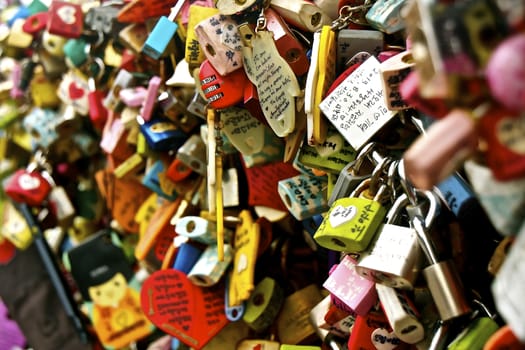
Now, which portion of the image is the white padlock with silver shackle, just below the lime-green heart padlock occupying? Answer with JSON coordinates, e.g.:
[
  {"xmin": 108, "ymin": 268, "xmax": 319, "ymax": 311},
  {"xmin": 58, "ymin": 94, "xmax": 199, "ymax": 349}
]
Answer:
[{"xmin": 355, "ymin": 189, "xmax": 439, "ymax": 289}]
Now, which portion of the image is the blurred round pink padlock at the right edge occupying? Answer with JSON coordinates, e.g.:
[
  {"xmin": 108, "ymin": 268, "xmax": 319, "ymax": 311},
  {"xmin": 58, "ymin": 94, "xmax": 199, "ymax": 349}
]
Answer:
[{"xmin": 486, "ymin": 34, "xmax": 525, "ymax": 111}]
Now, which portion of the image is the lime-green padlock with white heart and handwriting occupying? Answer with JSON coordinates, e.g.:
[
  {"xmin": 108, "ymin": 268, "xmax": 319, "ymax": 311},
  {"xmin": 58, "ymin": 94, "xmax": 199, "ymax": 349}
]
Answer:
[{"xmin": 314, "ymin": 179, "xmax": 387, "ymax": 252}]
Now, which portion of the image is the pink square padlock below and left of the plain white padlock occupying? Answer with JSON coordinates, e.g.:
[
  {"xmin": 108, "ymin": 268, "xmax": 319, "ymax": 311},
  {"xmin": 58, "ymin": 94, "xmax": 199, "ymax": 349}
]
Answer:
[{"xmin": 323, "ymin": 255, "xmax": 377, "ymax": 316}]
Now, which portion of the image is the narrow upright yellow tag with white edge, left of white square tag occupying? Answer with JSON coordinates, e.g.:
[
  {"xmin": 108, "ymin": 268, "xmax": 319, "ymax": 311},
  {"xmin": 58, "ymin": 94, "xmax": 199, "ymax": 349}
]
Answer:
[{"xmin": 304, "ymin": 26, "xmax": 336, "ymax": 145}]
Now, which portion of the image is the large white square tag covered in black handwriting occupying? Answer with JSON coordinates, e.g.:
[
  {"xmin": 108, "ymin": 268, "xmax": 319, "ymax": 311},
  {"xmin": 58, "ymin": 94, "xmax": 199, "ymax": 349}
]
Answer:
[{"xmin": 319, "ymin": 56, "xmax": 396, "ymax": 149}]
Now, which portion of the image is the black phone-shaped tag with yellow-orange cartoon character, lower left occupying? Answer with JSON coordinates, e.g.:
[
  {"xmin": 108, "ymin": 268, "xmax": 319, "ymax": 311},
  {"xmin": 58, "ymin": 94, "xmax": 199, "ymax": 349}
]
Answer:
[{"xmin": 67, "ymin": 231, "xmax": 154, "ymax": 349}]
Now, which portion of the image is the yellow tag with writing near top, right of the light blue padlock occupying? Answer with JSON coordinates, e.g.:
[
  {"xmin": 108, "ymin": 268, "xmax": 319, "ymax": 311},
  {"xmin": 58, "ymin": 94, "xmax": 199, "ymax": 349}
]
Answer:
[{"xmin": 184, "ymin": 4, "xmax": 219, "ymax": 71}]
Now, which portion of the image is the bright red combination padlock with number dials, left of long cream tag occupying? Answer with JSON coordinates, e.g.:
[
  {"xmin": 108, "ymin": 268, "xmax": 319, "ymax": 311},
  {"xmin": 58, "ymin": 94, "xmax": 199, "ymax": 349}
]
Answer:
[{"xmin": 199, "ymin": 60, "xmax": 250, "ymax": 109}]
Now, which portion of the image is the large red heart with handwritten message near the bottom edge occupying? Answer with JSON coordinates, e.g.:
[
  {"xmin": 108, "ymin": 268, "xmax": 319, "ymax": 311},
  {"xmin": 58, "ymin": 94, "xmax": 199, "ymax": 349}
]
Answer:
[{"xmin": 140, "ymin": 269, "xmax": 228, "ymax": 349}]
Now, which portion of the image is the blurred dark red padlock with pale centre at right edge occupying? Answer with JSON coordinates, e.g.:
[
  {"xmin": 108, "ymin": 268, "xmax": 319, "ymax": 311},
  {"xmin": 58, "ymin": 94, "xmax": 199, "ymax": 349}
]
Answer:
[{"xmin": 479, "ymin": 106, "xmax": 525, "ymax": 181}]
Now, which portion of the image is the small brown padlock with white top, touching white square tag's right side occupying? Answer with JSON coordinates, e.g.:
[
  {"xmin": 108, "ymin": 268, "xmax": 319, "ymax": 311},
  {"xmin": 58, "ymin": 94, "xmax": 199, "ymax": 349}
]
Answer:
[{"xmin": 380, "ymin": 51, "xmax": 414, "ymax": 110}]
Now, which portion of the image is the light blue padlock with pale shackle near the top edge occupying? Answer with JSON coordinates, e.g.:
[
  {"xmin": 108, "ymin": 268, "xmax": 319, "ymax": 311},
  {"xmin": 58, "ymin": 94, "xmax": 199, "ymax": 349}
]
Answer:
[{"xmin": 142, "ymin": 0, "xmax": 185, "ymax": 60}]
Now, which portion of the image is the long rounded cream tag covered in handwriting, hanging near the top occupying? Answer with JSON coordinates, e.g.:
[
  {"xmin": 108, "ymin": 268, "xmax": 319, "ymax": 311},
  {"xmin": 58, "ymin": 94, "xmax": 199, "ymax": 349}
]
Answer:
[{"xmin": 239, "ymin": 26, "xmax": 301, "ymax": 137}]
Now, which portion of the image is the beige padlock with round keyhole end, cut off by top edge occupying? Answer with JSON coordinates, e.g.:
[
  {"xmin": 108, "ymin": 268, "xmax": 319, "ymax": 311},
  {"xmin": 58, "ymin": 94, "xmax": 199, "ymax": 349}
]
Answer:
[{"xmin": 270, "ymin": 0, "xmax": 332, "ymax": 33}]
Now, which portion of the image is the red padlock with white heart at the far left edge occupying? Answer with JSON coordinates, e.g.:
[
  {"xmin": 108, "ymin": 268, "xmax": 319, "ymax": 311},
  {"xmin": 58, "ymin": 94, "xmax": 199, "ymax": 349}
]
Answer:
[{"xmin": 4, "ymin": 169, "xmax": 51, "ymax": 206}]
